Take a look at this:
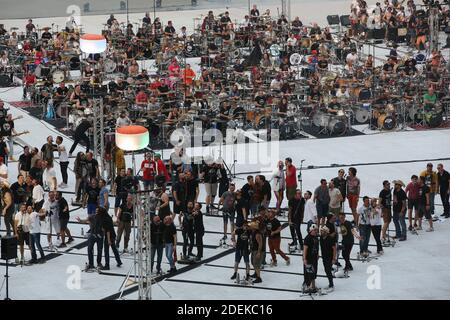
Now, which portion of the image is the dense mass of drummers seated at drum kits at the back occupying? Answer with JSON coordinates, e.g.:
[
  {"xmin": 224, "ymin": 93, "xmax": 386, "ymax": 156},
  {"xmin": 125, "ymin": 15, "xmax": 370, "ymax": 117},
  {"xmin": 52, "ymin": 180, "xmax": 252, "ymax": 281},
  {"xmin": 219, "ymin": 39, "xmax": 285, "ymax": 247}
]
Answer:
[{"xmin": 0, "ymin": 0, "xmax": 448, "ymax": 141}]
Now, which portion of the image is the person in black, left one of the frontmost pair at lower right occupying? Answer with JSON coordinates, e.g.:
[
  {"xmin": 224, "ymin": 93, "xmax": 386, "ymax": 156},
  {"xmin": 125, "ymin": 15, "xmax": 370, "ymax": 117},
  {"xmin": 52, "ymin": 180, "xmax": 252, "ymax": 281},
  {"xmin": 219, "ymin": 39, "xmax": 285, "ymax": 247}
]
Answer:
[{"xmin": 303, "ymin": 223, "xmax": 319, "ymax": 293}]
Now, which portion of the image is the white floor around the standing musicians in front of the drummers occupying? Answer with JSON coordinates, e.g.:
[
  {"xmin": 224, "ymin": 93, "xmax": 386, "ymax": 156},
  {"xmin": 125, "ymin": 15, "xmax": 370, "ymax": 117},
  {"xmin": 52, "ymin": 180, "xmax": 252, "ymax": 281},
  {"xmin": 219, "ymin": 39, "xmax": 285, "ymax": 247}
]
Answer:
[{"xmin": 0, "ymin": 88, "xmax": 450, "ymax": 300}]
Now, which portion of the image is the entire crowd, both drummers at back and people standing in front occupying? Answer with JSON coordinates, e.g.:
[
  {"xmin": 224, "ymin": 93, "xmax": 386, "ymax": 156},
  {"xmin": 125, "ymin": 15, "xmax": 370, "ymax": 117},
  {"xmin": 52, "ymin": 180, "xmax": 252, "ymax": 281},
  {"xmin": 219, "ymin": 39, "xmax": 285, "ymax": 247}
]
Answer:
[{"xmin": 0, "ymin": 0, "xmax": 450, "ymax": 292}]
